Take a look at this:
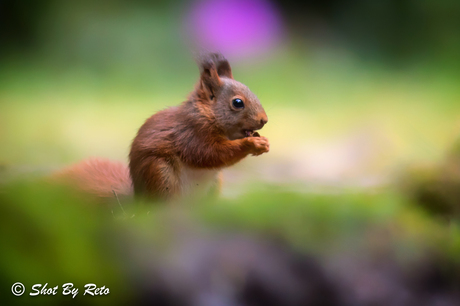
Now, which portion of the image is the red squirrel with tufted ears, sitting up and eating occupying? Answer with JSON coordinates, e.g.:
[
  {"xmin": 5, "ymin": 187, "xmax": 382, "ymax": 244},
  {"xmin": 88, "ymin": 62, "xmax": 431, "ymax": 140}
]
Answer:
[{"xmin": 58, "ymin": 53, "xmax": 270, "ymax": 201}]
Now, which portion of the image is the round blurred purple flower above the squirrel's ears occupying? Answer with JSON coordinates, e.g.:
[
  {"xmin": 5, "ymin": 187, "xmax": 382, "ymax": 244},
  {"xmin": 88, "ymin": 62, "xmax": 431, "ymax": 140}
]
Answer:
[{"xmin": 187, "ymin": 0, "xmax": 281, "ymax": 56}]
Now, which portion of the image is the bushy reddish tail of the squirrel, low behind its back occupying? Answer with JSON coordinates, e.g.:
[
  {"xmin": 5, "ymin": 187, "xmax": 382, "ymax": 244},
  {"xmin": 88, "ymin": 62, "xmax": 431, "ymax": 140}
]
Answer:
[{"xmin": 53, "ymin": 158, "xmax": 133, "ymax": 198}]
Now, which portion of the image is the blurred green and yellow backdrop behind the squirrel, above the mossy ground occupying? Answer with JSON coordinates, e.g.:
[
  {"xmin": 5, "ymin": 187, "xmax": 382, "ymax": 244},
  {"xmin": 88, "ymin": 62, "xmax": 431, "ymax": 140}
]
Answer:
[{"xmin": 0, "ymin": 0, "xmax": 460, "ymax": 185}]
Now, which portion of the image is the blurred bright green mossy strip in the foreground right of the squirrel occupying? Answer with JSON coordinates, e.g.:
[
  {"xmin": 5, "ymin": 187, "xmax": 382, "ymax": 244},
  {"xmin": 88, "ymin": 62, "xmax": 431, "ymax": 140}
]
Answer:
[{"xmin": 196, "ymin": 187, "xmax": 460, "ymax": 261}]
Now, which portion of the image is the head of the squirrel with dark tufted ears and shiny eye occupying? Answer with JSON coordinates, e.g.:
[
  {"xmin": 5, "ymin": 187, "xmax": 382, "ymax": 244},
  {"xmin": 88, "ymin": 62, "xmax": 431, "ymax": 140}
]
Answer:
[{"xmin": 197, "ymin": 53, "xmax": 268, "ymax": 140}]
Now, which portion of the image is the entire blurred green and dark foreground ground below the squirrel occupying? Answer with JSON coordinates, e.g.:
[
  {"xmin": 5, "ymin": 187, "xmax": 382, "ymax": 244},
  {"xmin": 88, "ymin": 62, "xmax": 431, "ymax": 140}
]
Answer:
[{"xmin": 0, "ymin": 177, "xmax": 460, "ymax": 306}]
